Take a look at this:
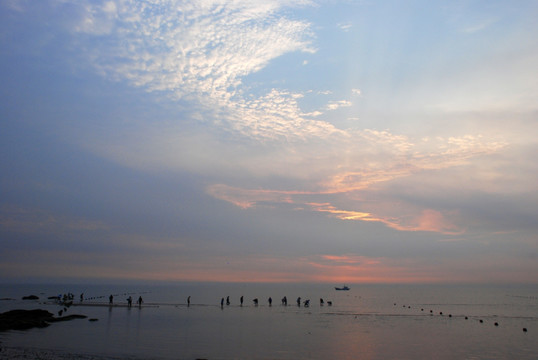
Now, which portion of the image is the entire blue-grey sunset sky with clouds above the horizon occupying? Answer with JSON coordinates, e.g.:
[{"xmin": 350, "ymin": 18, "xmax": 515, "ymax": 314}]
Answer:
[{"xmin": 0, "ymin": 0, "xmax": 538, "ymax": 285}]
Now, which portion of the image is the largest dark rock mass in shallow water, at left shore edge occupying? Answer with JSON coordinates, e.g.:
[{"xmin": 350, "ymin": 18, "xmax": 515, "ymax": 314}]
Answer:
[{"xmin": 0, "ymin": 309, "xmax": 87, "ymax": 331}]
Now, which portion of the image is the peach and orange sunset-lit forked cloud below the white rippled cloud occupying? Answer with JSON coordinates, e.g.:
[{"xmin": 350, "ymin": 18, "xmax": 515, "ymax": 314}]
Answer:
[{"xmin": 207, "ymin": 130, "xmax": 505, "ymax": 235}]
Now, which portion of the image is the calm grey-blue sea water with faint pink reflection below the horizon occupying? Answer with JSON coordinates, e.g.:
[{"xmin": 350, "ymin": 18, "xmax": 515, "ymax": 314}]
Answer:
[{"xmin": 0, "ymin": 284, "xmax": 538, "ymax": 359}]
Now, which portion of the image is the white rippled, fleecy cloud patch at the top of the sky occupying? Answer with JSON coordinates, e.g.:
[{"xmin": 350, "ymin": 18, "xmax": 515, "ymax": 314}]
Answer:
[{"xmin": 62, "ymin": 0, "xmax": 320, "ymax": 139}]
